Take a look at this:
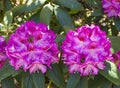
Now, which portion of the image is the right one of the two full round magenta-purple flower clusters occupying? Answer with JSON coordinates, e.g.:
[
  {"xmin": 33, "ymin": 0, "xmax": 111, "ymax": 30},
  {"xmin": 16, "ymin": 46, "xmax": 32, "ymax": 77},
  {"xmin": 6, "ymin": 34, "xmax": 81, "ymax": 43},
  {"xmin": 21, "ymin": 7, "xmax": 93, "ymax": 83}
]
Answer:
[{"xmin": 61, "ymin": 25, "xmax": 111, "ymax": 76}]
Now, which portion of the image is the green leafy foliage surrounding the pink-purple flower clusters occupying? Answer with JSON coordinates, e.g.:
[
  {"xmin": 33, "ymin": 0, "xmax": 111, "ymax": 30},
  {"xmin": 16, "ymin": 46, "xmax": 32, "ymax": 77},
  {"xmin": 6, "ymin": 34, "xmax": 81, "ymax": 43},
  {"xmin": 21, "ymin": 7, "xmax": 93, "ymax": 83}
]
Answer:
[{"xmin": 0, "ymin": 0, "xmax": 120, "ymax": 88}]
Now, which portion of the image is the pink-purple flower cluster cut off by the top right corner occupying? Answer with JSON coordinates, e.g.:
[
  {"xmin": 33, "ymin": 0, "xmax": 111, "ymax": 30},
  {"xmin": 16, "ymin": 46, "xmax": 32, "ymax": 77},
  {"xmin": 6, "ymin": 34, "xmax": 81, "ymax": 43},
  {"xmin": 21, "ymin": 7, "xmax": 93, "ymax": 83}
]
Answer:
[{"xmin": 102, "ymin": 0, "xmax": 120, "ymax": 17}]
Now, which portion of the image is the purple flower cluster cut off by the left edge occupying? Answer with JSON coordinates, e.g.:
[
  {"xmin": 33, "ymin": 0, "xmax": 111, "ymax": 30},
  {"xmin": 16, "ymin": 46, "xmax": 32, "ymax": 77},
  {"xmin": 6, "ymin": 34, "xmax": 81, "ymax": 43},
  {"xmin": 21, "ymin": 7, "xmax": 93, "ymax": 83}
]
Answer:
[{"xmin": 0, "ymin": 36, "xmax": 7, "ymax": 68}]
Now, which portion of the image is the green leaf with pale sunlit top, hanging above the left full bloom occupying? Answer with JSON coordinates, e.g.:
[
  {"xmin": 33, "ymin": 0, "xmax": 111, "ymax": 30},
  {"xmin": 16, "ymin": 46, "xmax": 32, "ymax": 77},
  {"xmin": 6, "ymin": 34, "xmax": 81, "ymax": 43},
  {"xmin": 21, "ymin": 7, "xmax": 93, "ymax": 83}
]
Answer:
[{"xmin": 40, "ymin": 4, "xmax": 53, "ymax": 25}]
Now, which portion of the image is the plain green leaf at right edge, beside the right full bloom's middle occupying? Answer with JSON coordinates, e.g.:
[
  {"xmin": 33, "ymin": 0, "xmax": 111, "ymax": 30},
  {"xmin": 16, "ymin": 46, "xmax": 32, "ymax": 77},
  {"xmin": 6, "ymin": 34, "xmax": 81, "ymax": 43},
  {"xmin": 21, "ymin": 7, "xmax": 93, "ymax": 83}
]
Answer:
[{"xmin": 108, "ymin": 36, "xmax": 120, "ymax": 52}]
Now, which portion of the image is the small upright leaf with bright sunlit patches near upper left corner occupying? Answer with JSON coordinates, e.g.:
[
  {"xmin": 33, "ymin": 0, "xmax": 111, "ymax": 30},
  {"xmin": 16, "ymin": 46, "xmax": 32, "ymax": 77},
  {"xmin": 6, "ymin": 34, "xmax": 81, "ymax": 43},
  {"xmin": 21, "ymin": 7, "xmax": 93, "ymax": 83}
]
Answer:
[{"xmin": 3, "ymin": 11, "xmax": 13, "ymax": 25}]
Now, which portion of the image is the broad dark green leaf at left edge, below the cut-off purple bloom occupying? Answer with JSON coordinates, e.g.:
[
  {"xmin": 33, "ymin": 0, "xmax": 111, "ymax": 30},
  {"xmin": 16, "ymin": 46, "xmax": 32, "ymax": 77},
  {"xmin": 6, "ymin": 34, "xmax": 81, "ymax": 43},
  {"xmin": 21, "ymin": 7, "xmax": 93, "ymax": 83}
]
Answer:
[{"xmin": 0, "ymin": 63, "xmax": 20, "ymax": 80}]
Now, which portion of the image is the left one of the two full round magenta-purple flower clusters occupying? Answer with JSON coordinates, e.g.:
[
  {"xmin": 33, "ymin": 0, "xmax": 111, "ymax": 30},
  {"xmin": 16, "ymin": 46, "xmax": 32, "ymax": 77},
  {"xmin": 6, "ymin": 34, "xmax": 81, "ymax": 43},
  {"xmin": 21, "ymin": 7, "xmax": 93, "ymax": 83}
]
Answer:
[{"xmin": 6, "ymin": 21, "xmax": 59, "ymax": 73}]
